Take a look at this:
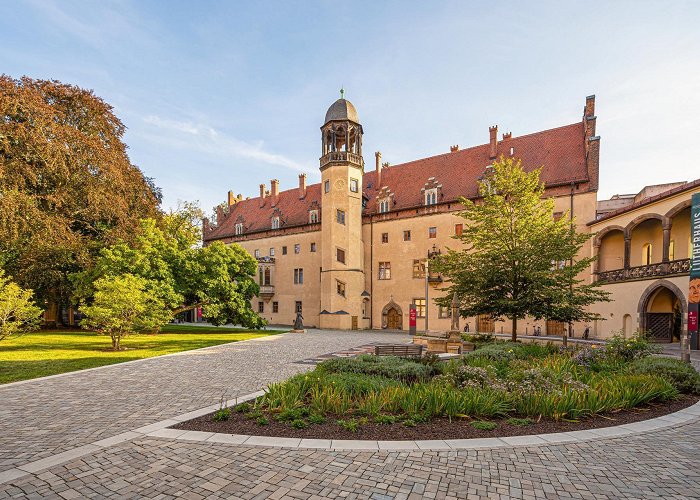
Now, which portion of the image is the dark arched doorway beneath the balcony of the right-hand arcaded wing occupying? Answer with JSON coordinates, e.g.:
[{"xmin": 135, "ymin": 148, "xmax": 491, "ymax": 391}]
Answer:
[{"xmin": 639, "ymin": 280, "xmax": 688, "ymax": 343}]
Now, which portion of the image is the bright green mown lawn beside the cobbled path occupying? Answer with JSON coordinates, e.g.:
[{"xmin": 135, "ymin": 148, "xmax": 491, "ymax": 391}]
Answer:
[{"xmin": 0, "ymin": 325, "xmax": 283, "ymax": 384}]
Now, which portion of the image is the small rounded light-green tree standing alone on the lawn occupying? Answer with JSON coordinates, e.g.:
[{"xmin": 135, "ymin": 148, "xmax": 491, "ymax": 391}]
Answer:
[{"xmin": 81, "ymin": 274, "xmax": 169, "ymax": 351}]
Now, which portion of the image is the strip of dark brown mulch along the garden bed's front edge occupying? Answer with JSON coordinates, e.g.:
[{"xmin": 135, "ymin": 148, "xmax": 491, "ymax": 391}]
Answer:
[{"xmin": 173, "ymin": 395, "xmax": 700, "ymax": 441}]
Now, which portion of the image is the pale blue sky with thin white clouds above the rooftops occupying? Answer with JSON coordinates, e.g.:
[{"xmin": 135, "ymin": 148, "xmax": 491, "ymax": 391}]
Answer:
[{"xmin": 0, "ymin": 0, "xmax": 700, "ymax": 215}]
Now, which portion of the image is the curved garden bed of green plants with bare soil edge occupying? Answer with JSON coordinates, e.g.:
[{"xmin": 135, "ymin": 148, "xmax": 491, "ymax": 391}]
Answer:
[{"xmin": 171, "ymin": 337, "xmax": 700, "ymax": 440}]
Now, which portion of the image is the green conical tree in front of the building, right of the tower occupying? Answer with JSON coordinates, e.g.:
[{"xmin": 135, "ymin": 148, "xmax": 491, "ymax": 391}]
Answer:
[{"xmin": 434, "ymin": 157, "xmax": 609, "ymax": 341}]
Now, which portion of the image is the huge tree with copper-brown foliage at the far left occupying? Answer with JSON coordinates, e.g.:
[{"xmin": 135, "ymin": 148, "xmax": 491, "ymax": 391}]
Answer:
[{"xmin": 0, "ymin": 75, "xmax": 160, "ymax": 310}]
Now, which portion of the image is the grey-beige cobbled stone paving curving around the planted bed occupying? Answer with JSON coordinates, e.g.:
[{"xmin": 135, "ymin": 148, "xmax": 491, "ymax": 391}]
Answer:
[{"xmin": 0, "ymin": 332, "xmax": 700, "ymax": 499}]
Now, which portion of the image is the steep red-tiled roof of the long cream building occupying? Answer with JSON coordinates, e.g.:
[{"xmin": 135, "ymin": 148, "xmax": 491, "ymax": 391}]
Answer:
[{"xmin": 205, "ymin": 122, "xmax": 588, "ymax": 240}]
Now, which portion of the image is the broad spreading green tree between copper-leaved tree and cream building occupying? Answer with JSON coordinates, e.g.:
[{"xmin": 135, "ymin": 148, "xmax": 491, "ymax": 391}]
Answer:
[{"xmin": 74, "ymin": 204, "xmax": 265, "ymax": 328}]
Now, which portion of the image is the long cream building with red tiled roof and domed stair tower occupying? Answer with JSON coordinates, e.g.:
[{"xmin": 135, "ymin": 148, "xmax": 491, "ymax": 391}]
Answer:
[{"xmin": 203, "ymin": 96, "xmax": 700, "ymax": 336}]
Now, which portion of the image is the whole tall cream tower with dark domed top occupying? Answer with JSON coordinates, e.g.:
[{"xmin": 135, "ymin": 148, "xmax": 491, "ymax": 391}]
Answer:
[{"xmin": 319, "ymin": 90, "xmax": 365, "ymax": 330}]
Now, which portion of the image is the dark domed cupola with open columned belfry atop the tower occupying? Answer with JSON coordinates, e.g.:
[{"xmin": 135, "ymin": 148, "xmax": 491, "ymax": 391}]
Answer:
[{"xmin": 320, "ymin": 89, "xmax": 364, "ymax": 170}]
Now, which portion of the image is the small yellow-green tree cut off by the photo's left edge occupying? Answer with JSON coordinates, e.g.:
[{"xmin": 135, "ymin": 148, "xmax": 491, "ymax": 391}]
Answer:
[{"xmin": 0, "ymin": 270, "xmax": 42, "ymax": 340}]
